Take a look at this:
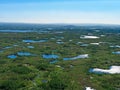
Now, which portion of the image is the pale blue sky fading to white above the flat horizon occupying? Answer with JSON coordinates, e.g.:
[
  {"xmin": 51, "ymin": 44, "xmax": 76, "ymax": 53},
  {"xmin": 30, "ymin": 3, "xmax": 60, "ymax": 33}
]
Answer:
[{"xmin": 0, "ymin": 0, "xmax": 120, "ymax": 24}]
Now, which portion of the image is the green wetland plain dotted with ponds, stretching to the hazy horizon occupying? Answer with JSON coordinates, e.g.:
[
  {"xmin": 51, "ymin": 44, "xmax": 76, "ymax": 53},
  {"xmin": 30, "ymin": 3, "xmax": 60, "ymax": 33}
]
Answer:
[{"xmin": 0, "ymin": 24, "xmax": 120, "ymax": 90}]
